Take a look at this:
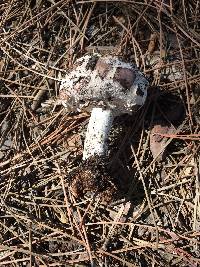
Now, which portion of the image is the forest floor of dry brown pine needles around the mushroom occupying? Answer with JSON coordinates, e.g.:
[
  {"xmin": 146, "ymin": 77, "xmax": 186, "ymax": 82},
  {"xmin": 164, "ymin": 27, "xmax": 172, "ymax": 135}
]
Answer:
[{"xmin": 0, "ymin": 0, "xmax": 200, "ymax": 267}]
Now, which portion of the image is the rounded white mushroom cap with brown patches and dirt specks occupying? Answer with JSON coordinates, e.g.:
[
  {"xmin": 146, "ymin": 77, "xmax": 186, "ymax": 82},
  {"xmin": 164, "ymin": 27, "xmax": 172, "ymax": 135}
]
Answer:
[{"xmin": 59, "ymin": 54, "xmax": 149, "ymax": 114}]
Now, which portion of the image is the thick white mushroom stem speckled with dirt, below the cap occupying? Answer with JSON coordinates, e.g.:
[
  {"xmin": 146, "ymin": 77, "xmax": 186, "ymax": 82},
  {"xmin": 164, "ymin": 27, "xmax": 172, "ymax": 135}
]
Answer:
[{"xmin": 83, "ymin": 108, "xmax": 114, "ymax": 160}]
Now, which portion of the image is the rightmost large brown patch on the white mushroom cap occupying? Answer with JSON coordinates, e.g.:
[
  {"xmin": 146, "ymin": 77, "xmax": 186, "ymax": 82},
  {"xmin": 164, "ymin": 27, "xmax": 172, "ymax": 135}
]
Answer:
[{"xmin": 114, "ymin": 68, "xmax": 135, "ymax": 89}]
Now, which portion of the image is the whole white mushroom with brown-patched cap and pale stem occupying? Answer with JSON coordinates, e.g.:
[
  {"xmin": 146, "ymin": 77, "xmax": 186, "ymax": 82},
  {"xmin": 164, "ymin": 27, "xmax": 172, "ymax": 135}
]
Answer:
[{"xmin": 60, "ymin": 54, "xmax": 149, "ymax": 160}]
